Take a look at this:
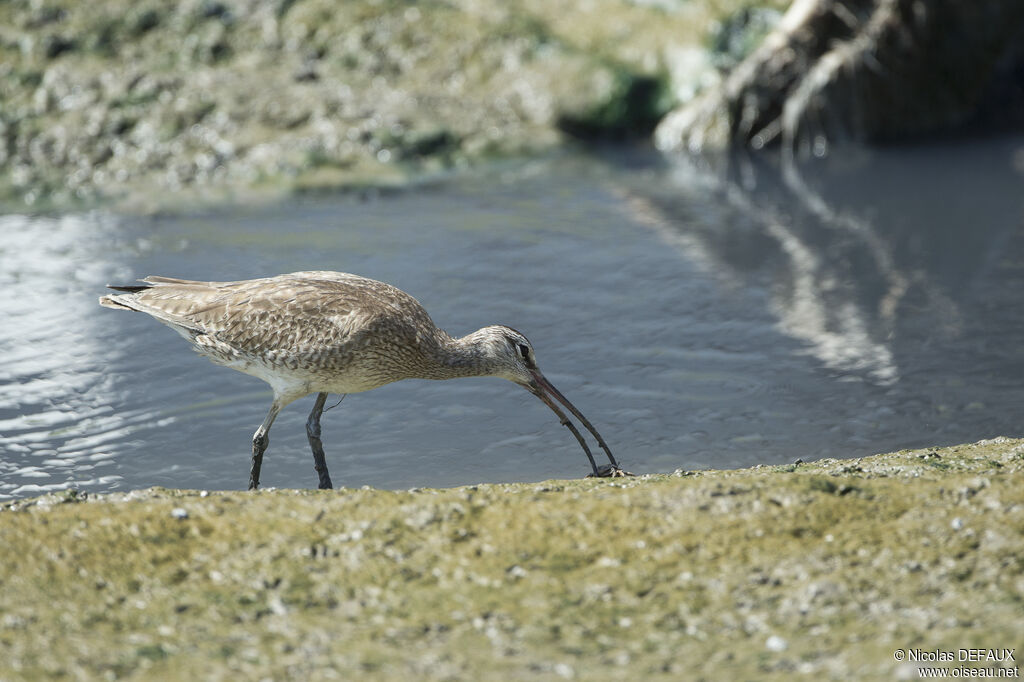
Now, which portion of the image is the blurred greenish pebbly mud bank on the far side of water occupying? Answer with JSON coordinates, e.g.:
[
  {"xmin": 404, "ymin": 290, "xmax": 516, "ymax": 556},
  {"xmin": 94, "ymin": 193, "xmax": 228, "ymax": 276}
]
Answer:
[{"xmin": 0, "ymin": 0, "xmax": 781, "ymax": 204}]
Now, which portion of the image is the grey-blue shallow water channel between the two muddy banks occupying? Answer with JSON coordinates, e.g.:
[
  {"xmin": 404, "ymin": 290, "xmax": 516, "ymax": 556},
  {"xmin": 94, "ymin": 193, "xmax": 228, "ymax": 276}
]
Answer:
[{"xmin": 0, "ymin": 138, "xmax": 1024, "ymax": 497}]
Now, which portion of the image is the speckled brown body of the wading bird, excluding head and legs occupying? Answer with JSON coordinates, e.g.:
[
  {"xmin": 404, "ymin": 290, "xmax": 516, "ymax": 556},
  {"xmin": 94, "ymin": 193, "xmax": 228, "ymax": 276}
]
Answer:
[{"xmin": 100, "ymin": 271, "xmax": 487, "ymax": 402}]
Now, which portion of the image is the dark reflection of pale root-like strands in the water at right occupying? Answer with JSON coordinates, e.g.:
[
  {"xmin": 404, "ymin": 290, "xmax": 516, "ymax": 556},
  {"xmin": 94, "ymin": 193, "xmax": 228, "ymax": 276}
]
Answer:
[{"xmin": 629, "ymin": 135, "xmax": 1024, "ymax": 386}]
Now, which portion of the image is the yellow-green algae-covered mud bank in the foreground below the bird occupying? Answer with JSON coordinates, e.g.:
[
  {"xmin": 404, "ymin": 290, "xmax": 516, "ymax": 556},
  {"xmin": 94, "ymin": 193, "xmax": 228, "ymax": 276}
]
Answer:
[{"xmin": 0, "ymin": 438, "xmax": 1024, "ymax": 680}]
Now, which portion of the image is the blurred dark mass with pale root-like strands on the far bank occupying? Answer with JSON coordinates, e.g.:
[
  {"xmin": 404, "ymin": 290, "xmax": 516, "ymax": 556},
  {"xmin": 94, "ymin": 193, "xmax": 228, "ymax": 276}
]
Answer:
[{"xmin": 657, "ymin": 0, "xmax": 1024, "ymax": 156}]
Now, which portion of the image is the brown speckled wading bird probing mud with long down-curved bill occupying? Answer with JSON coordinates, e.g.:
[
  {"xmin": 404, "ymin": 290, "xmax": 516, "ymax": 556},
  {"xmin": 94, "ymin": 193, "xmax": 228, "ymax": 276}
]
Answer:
[{"xmin": 99, "ymin": 271, "xmax": 629, "ymax": 489}]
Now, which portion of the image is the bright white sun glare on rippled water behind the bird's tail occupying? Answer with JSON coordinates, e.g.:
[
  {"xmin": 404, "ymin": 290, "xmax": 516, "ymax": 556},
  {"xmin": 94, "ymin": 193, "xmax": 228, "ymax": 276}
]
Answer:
[{"xmin": 0, "ymin": 215, "xmax": 132, "ymax": 495}]
